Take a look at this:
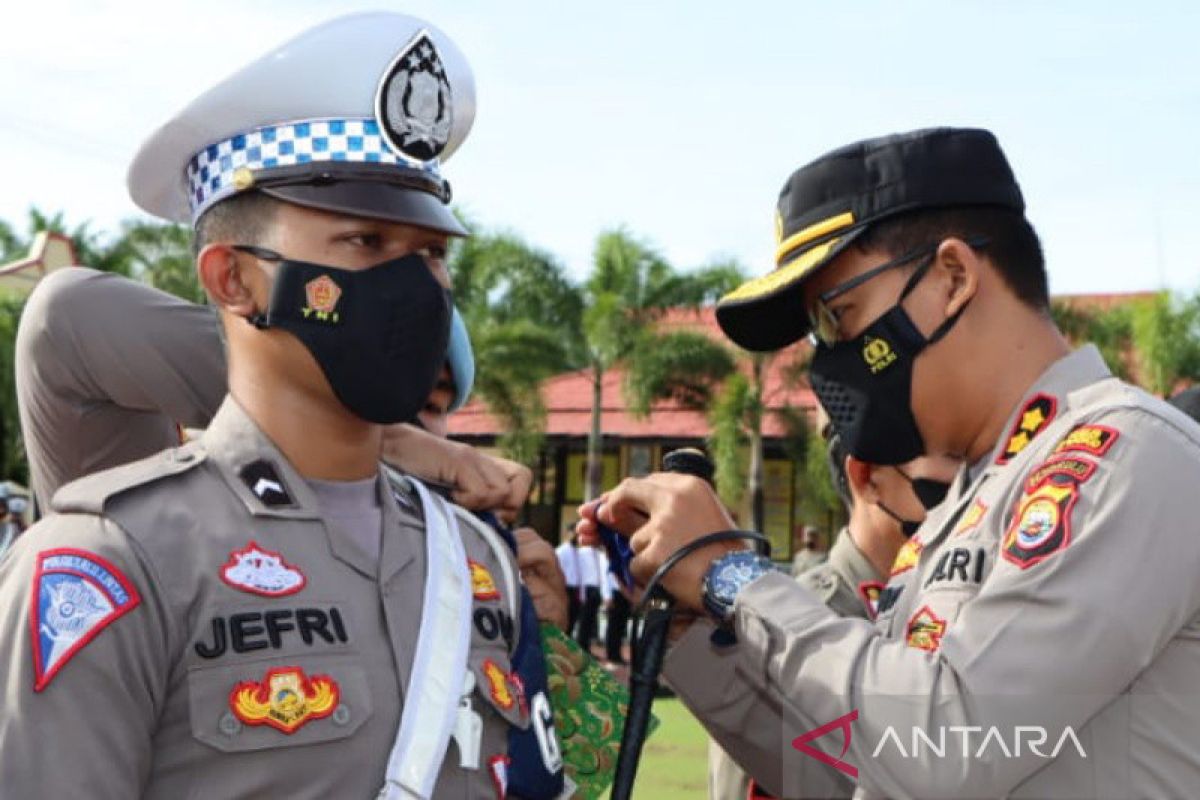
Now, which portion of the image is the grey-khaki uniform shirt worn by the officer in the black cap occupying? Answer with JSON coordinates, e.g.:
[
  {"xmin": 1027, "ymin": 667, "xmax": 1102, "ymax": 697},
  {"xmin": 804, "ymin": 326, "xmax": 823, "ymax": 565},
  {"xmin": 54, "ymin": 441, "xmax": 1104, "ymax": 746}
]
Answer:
[{"xmin": 666, "ymin": 347, "xmax": 1200, "ymax": 798}]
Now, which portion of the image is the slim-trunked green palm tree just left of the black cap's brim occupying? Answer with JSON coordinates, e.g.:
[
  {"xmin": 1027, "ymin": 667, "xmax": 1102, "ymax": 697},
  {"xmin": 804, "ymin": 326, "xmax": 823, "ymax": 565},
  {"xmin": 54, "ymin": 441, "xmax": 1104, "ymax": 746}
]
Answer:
[{"xmin": 582, "ymin": 228, "xmax": 742, "ymax": 500}]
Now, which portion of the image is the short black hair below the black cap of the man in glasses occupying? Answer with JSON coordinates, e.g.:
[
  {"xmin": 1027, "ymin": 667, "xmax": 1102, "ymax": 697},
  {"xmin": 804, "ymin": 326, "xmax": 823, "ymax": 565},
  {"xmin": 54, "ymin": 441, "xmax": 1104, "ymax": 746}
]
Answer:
[{"xmin": 854, "ymin": 206, "xmax": 1050, "ymax": 313}]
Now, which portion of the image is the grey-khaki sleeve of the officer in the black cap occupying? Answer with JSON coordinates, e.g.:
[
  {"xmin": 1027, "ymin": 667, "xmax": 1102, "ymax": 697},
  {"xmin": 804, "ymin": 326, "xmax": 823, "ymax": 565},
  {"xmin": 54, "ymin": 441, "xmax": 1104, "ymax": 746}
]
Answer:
[{"xmin": 677, "ymin": 411, "xmax": 1200, "ymax": 796}]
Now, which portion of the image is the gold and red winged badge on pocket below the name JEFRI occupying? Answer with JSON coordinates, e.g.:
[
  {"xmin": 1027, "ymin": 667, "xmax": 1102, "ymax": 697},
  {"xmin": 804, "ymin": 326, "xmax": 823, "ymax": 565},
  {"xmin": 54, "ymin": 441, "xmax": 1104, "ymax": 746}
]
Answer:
[{"xmin": 229, "ymin": 667, "xmax": 338, "ymax": 735}]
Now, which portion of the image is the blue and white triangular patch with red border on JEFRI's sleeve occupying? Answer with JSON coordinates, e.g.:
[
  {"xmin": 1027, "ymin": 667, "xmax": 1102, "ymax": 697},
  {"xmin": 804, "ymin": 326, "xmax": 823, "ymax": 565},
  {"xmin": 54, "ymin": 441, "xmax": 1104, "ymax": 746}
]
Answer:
[{"xmin": 29, "ymin": 547, "xmax": 142, "ymax": 692}]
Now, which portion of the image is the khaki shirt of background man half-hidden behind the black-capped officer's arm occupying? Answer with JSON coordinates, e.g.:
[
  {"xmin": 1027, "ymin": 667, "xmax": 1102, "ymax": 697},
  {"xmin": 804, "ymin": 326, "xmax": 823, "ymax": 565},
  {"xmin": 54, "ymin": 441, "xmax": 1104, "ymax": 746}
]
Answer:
[{"xmin": 708, "ymin": 528, "xmax": 883, "ymax": 800}]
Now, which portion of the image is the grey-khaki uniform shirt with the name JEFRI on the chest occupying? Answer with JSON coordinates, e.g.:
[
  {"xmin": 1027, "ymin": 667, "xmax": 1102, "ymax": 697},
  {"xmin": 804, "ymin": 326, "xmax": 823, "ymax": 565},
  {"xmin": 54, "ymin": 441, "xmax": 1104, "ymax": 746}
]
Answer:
[{"xmin": 0, "ymin": 399, "xmax": 528, "ymax": 800}]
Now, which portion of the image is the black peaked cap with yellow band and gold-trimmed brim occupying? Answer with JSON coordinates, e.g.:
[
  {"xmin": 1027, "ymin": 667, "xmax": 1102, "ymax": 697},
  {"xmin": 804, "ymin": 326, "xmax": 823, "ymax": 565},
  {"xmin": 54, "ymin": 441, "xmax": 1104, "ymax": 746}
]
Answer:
[{"xmin": 716, "ymin": 128, "xmax": 1025, "ymax": 351}]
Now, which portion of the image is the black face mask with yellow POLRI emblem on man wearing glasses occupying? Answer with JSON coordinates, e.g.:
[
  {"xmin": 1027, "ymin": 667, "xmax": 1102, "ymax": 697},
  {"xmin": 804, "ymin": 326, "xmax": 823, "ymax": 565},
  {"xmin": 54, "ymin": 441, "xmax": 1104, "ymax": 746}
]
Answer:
[{"xmin": 809, "ymin": 257, "xmax": 966, "ymax": 465}]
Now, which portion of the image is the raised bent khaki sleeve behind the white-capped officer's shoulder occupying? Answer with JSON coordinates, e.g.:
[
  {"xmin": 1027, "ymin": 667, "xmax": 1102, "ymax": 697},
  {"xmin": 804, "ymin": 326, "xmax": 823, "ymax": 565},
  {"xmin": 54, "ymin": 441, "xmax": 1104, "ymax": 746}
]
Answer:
[{"xmin": 16, "ymin": 267, "xmax": 226, "ymax": 509}]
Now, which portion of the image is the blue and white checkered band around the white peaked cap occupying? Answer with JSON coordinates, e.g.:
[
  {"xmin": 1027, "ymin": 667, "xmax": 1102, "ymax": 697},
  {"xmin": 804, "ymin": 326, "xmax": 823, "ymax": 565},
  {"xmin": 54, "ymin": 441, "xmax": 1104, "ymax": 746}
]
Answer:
[{"xmin": 187, "ymin": 119, "xmax": 440, "ymax": 223}]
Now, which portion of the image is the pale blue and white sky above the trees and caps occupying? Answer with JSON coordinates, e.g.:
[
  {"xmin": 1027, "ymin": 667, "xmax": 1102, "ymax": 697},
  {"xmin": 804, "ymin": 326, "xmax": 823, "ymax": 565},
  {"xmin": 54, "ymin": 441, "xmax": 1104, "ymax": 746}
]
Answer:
[{"xmin": 0, "ymin": 0, "xmax": 1200, "ymax": 293}]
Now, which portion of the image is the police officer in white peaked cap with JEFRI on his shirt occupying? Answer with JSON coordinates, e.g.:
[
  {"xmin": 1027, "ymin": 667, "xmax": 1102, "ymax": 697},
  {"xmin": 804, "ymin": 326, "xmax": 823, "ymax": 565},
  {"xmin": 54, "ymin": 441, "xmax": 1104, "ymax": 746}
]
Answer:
[{"xmin": 0, "ymin": 13, "xmax": 528, "ymax": 798}]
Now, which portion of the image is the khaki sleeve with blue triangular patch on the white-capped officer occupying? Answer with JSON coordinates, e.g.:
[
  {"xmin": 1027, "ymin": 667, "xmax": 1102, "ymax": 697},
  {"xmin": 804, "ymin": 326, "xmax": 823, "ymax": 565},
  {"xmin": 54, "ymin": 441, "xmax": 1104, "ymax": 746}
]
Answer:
[{"xmin": 0, "ymin": 515, "xmax": 170, "ymax": 800}]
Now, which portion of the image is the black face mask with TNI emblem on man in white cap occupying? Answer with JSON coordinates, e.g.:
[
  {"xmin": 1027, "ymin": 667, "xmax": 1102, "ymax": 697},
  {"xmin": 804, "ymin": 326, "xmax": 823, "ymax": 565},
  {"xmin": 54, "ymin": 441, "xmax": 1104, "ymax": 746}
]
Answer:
[{"xmin": 246, "ymin": 247, "xmax": 451, "ymax": 425}]
